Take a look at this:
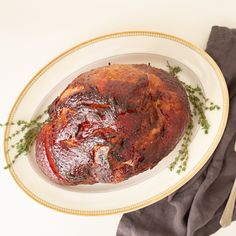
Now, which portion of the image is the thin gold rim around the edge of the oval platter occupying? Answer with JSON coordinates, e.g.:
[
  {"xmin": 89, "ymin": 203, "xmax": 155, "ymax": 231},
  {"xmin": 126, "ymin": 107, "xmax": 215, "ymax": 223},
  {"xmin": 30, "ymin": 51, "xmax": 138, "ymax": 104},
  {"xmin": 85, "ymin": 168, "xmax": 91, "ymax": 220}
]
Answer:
[{"xmin": 4, "ymin": 31, "xmax": 229, "ymax": 216}]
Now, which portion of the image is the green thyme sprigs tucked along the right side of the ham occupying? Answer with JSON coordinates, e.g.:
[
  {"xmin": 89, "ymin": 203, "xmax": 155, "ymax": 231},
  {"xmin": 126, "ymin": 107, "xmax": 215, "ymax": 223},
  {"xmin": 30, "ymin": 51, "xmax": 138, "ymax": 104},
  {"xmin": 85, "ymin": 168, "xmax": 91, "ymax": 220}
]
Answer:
[{"xmin": 167, "ymin": 61, "xmax": 220, "ymax": 174}]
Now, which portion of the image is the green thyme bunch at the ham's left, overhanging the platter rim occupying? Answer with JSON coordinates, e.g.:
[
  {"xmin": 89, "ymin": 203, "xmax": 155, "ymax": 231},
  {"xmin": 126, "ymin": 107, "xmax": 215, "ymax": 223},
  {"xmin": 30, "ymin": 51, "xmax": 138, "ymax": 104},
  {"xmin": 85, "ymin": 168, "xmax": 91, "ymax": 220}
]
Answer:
[{"xmin": 0, "ymin": 110, "xmax": 50, "ymax": 169}]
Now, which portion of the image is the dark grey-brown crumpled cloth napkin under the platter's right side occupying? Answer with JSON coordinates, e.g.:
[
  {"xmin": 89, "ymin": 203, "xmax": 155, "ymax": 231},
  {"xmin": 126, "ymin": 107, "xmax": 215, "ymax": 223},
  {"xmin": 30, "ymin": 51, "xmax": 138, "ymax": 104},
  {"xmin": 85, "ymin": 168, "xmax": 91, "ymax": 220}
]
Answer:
[{"xmin": 117, "ymin": 26, "xmax": 236, "ymax": 236}]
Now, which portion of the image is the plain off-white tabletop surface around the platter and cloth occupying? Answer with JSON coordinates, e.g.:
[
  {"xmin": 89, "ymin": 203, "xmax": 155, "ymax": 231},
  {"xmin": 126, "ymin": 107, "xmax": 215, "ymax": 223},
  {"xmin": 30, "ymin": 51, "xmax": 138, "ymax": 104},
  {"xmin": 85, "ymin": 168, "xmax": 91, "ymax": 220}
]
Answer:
[{"xmin": 0, "ymin": 0, "xmax": 236, "ymax": 236}]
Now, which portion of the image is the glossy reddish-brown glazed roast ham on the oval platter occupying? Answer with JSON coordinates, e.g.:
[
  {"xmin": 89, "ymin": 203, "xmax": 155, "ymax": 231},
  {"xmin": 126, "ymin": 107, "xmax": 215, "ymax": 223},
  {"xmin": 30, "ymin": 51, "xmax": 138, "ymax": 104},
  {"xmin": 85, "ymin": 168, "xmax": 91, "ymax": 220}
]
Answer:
[{"xmin": 36, "ymin": 64, "xmax": 190, "ymax": 185}]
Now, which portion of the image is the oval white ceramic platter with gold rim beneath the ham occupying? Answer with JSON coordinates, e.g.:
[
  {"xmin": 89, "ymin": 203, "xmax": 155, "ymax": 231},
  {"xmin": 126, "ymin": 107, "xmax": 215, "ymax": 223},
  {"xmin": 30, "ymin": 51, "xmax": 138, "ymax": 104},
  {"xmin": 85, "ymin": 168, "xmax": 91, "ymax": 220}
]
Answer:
[{"xmin": 5, "ymin": 31, "xmax": 228, "ymax": 215}]
